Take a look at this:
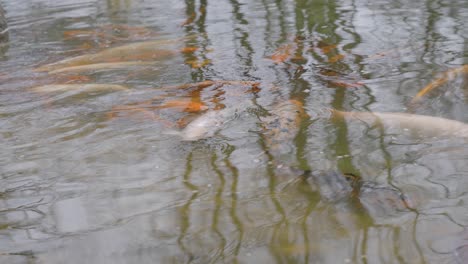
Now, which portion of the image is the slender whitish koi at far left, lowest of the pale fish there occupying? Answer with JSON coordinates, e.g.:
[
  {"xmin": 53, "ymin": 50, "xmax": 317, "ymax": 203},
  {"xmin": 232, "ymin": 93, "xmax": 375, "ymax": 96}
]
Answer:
[{"xmin": 31, "ymin": 83, "xmax": 128, "ymax": 93}]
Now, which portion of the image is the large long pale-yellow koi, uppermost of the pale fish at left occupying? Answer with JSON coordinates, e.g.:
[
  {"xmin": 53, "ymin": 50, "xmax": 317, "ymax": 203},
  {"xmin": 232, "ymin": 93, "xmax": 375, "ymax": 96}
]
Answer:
[{"xmin": 36, "ymin": 41, "xmax": 176, "ymax": 71}]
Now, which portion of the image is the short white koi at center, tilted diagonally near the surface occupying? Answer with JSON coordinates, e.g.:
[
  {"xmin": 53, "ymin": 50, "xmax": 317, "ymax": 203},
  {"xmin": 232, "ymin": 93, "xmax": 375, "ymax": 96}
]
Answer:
[{"xmin": 167, "ymin": 107, "xmax": 243, "ymax": 141}]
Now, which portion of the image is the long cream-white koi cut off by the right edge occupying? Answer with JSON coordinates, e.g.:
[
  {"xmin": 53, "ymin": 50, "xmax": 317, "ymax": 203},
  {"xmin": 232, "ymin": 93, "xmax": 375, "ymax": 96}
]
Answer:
[{"xmin": 332, "ymin": 110, "xmax": 468, "ymax": 137}]
